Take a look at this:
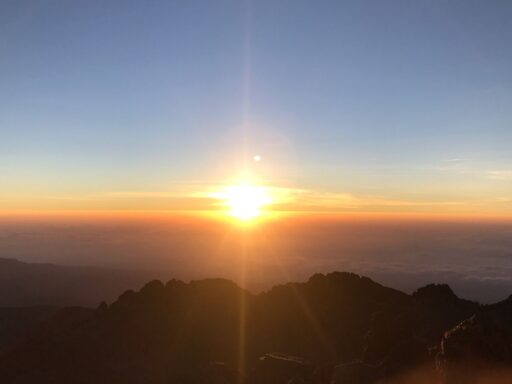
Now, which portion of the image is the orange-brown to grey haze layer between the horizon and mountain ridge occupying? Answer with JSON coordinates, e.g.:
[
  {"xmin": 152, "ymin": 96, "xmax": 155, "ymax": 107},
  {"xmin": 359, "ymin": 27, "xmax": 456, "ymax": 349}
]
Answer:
[{"xmin": 0, "ymin": 214, "xmax": 512, "ymax": 302}]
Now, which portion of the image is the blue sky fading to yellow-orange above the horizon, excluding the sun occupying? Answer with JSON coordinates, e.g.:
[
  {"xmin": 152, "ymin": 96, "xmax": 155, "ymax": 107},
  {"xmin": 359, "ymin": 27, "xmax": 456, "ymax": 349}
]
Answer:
[{"xmin": 0, "ymin": 0, "xmax": 512, "ymax": 217}]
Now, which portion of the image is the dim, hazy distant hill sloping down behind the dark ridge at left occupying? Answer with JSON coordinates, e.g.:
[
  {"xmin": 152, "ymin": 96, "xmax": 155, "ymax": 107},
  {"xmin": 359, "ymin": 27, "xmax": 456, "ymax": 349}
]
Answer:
[{"xmin": 0, "ymin": 258, "xmax": 152, "ymax": 307}]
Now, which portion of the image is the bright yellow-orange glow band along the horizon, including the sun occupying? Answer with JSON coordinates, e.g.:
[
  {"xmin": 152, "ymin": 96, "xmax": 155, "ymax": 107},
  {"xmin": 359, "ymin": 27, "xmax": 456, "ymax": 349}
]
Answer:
[{"xmin": 0, "ymin": 184, "xmax": 512, "ymax": 220}]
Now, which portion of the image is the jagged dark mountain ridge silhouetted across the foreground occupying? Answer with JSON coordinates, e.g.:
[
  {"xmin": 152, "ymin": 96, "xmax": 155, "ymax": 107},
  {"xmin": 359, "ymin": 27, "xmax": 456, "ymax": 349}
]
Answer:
[{"xmin": 0, "ymin": 272, "xmax": 512, "ymax": 384}]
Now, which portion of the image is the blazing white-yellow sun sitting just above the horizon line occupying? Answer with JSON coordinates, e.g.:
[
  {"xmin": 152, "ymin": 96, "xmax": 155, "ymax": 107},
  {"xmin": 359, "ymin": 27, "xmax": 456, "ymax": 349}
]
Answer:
[{"xmin": 220, "ymin": 182, "xmax": 272, "ymax": 221}]
